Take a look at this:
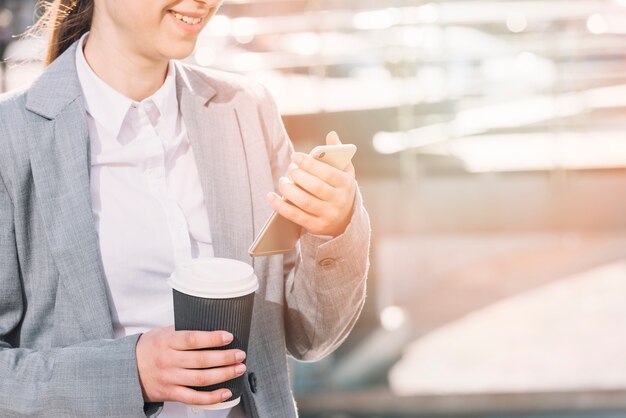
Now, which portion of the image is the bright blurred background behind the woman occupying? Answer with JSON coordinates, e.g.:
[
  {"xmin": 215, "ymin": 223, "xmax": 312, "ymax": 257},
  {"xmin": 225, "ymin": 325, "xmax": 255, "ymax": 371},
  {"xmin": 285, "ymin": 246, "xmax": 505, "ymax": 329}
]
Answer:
[{"xmin": 0, "ymin": 0, "xmax": 626, "ymax": 418}]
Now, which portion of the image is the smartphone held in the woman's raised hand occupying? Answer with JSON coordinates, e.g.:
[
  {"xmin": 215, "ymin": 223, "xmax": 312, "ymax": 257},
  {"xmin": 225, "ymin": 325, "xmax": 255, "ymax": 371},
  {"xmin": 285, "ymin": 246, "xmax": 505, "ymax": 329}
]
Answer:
[{"xmin": 248, "ymin": 144, "xmax": 356, "ymax": 257}]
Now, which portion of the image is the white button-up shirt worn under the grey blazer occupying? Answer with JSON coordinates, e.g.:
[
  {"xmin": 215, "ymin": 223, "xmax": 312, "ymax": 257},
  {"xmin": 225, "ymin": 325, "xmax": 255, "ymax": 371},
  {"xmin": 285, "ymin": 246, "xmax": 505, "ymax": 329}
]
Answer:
[{"xmin": 76, "ymin": 33, "xmax": 239, "ymax": 418}]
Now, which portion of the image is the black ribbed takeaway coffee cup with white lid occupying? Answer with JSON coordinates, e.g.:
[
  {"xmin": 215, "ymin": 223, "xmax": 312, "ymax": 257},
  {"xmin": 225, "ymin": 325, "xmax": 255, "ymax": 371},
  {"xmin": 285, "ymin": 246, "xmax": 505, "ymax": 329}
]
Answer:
[{"xmin": 168, "ymin": 258, "xmax": 259, "ymax": 409}]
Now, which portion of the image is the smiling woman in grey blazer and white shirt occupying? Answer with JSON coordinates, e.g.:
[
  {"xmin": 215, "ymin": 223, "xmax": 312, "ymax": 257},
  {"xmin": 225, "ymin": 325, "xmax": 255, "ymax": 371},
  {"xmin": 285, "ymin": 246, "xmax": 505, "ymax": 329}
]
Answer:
[{"xmin": 0, "ymin": 0, "xmax": 369, "ymax": 418}]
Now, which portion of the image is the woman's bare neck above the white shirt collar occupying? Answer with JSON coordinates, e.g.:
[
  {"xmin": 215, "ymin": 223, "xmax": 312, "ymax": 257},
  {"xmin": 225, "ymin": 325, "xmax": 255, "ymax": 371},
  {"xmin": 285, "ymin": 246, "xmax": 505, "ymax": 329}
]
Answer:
[{"xmin": 83, "ymin": 27, "xmax": 168, "ymax": 102}]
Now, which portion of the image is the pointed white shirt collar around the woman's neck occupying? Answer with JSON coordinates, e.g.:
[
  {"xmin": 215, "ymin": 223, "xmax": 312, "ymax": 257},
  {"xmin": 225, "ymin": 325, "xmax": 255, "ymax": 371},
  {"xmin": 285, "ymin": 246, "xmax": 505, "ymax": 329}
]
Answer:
[{"xmin": 76, "ymin": 32, "xmax": 178, "ymax": 138}]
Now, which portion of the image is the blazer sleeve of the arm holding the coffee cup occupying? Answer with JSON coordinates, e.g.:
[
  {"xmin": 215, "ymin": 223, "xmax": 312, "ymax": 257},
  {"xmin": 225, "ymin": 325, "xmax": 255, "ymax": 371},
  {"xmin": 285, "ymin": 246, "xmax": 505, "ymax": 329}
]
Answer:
[{"xmin": 0, "ymin": 174, "xmax": 150, "ymax": 418}]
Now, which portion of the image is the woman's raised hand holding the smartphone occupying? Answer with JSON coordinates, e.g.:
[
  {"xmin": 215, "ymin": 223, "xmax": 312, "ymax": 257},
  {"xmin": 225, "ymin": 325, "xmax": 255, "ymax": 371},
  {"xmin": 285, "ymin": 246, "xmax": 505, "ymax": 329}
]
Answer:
[{"xmin": 267, "ymin": 132, "xmax": 356, "ymax": 237}]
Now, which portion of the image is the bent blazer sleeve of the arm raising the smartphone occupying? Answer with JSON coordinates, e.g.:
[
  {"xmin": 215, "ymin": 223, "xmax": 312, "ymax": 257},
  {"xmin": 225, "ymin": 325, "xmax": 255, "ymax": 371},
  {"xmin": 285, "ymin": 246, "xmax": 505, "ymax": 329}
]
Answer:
[{"xmin": 255, "ymin": 84, "xmax": 371, "ymax": 361}]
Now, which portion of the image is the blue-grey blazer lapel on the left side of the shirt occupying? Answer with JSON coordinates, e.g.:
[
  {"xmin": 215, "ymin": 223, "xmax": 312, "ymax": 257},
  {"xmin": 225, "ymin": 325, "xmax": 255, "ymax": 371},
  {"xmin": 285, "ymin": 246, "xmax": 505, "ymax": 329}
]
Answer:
[{"xmin": 26, "ymin": 43, "xmax": 113, "ymax": 339}]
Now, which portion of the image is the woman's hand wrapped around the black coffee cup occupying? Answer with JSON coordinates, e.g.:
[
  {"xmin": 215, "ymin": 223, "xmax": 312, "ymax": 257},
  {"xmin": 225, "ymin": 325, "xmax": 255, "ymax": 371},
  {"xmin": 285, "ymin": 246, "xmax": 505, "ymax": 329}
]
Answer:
[{"xmin": 136, "ymin": 326, "xmax": 246, "ymax": 405}]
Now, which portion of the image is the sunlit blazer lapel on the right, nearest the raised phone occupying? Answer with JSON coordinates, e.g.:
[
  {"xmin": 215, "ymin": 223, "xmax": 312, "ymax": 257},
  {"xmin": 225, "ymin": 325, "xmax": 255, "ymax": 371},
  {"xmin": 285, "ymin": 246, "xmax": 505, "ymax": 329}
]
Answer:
[{"xmin": 176, "ymin": 65, "xmax": 254, "ymax": 264}]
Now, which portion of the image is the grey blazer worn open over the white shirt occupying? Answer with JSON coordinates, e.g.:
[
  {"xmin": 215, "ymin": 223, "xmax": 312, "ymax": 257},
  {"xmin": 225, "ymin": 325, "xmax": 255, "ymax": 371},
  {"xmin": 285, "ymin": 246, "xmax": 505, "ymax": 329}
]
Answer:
[{"xmin": 0, "ymin": 43, "xmax": 370, "ymax": 418}]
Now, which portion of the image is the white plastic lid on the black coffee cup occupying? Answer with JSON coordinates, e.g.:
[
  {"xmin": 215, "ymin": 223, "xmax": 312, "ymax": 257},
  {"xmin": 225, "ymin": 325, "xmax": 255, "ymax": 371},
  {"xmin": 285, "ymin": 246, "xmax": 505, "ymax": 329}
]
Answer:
[{"xmin": 167, "ymin": 257, "xmax": 259, "ymax": 299}]
